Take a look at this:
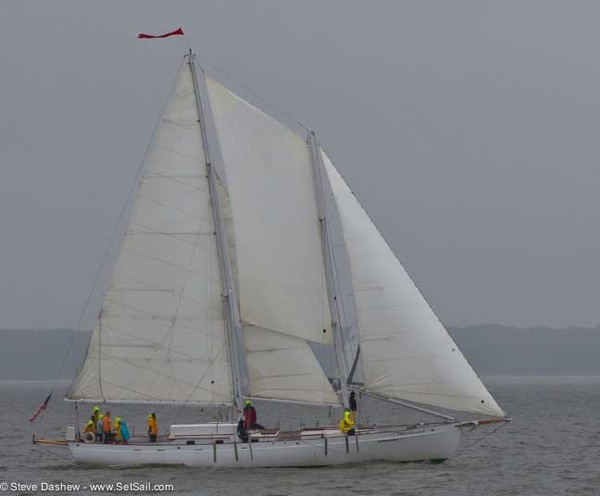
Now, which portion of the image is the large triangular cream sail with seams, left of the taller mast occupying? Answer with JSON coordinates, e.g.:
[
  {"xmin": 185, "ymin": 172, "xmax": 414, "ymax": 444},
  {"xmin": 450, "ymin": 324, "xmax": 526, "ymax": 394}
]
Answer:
[{"xmin": 67, "ymin": 64, "xmax": 233, "ymax": 404}]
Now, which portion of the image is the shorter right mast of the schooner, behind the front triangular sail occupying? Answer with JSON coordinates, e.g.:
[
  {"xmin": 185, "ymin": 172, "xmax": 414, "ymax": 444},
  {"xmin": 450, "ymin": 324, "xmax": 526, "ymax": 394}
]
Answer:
[{"xmin": 308, "ymin": 131, "xmax": 348, "ymax": 407}]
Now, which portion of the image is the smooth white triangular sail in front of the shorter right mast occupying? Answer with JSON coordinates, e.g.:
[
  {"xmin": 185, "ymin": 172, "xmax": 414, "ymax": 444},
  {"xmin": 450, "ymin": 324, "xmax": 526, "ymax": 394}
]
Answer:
[{"xmin": 322, "ymin": 152, "xmax": 504, "ymax": 415}]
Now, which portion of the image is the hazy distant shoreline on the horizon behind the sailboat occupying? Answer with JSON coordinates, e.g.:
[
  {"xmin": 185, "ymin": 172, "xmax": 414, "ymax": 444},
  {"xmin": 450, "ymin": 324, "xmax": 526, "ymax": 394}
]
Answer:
[{"xmin": 0, "ymin": 324, "xmax": 600, "ymax": 384}]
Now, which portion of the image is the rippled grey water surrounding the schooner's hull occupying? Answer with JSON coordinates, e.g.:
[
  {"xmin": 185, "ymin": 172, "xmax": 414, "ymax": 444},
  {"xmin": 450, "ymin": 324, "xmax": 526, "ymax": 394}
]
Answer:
[{"xmin": 0, "ymin": 377, "xmax": 600, "ymax": 496}]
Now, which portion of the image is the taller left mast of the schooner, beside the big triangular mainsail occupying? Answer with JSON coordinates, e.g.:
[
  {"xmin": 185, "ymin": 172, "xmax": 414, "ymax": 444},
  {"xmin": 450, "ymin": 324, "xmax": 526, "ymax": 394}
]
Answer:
[{"xmin": 187, "ymin": 50, "xmax": 247, "ymax": 411}]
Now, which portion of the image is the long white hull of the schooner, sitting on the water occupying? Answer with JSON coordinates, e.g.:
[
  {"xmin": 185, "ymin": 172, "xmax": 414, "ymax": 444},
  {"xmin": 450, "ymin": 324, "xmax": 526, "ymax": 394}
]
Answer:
[{"xmin": 68, "ymin": 424, "xmax": 462, "ymax": 467}]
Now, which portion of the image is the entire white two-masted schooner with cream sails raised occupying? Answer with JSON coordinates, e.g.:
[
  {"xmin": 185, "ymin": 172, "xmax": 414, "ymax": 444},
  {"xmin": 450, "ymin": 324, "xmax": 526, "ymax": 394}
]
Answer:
[{"xmin": 55, "ymin": 51, "xmax": 509, "ymax": 468}]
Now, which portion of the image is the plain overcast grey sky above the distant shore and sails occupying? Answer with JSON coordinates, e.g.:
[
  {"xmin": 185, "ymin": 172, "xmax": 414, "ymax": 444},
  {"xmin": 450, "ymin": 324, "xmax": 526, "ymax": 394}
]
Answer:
[{"xmin": 0, "ymin": 0, "xmax": 600, "ymax": 328}]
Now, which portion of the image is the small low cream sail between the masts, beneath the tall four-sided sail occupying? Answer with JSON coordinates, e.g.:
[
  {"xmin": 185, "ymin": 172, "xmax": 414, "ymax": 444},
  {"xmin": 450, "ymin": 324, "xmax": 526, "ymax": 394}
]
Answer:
[{"xmin": 244, "ymin": 326, "xmax": 339, "ymax": 405}]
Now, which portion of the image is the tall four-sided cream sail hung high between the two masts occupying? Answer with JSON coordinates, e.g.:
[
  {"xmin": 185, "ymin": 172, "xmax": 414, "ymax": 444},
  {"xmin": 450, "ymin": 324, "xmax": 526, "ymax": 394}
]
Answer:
[{"xmin": 206, "ymin": 78, "xmax": 332, "ymax": 343}]
